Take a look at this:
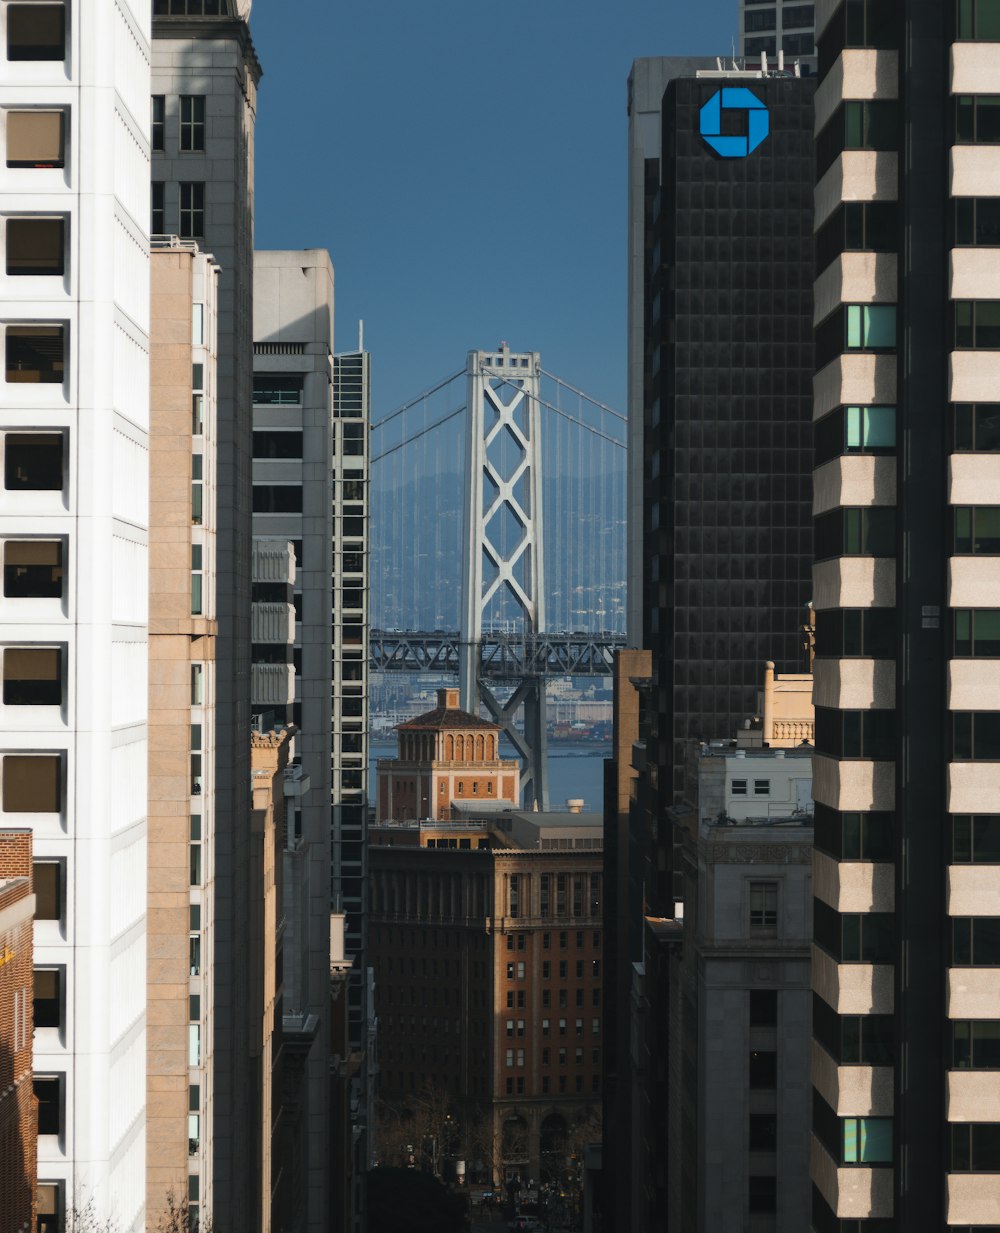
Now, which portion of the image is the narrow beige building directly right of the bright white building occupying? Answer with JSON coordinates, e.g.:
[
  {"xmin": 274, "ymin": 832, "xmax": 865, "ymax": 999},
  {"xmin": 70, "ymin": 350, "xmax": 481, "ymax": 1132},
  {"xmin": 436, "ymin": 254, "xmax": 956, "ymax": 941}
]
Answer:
[{"xmin": 145, "ymin": 239, "xmax": 218, "ymax": 1219}]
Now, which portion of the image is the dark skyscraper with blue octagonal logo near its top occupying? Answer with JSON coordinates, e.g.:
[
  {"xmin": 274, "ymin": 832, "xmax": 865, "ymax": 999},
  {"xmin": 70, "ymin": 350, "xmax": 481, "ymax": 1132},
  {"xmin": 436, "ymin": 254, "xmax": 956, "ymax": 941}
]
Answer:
[{"xmin": 644, "ymin": 73, "xmax": 814, "ymax": 808}]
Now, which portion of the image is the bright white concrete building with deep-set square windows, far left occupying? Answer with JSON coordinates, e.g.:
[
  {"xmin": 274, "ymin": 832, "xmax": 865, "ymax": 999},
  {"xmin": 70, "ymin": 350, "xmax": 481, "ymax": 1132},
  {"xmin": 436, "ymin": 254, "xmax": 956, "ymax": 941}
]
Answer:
[{"xmin": 0, "ymin": 0, "xmax": 150, "ymax": 1231}]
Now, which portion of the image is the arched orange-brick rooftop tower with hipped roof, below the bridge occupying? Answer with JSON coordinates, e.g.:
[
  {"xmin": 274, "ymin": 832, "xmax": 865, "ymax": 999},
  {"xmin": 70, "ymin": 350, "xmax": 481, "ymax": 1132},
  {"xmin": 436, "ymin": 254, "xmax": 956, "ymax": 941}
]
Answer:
[{"xmin": 376, "ymin": 689, "xmax": 520, "ymax": 821}]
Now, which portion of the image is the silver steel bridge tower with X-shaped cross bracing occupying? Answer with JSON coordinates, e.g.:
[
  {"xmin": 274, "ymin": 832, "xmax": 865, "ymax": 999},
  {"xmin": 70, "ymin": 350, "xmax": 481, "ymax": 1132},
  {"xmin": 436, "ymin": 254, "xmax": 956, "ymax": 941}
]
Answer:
[{"xmin": 459, "ymin": 343, "xmax": 549, "ymax": 809}]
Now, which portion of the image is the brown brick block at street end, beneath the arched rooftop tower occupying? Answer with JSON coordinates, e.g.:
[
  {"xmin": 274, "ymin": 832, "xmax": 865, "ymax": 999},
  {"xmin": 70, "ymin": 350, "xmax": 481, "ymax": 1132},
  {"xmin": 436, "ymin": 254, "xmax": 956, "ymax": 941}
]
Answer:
[{"xmin": 369, "ymin": 805, "xmax": 603, "ymax": 1181}]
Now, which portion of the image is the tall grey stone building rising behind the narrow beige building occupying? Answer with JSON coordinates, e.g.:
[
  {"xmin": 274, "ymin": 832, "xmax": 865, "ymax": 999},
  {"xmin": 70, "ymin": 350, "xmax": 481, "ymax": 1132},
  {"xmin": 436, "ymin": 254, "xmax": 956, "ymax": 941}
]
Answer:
[{"xmin": 145, "ymin": 7, "xmax": 260, "ymax": 1233}]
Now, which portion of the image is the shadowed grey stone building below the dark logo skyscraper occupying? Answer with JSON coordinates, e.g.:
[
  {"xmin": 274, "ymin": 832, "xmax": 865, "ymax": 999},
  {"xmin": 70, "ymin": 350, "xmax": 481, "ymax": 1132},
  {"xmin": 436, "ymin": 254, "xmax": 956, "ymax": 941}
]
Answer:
[{"xmin": 665, "ymin": 748, "xmax": 813, "ymax": 1233}]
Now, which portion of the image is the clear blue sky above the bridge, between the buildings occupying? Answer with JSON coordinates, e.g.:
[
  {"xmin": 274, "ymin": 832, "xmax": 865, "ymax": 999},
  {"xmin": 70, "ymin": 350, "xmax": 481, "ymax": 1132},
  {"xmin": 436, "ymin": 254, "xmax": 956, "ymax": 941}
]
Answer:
[{"xmin": 252, "ymin": 0, "xmax": 737, "ymax": 418}]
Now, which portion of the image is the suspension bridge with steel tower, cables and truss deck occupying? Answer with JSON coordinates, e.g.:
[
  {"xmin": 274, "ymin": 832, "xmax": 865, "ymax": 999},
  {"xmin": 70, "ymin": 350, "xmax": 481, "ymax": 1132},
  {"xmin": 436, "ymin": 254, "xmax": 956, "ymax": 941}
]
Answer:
[{"xmin": 370, "ymin": 343, "xmax": 626, "ymax": 808}]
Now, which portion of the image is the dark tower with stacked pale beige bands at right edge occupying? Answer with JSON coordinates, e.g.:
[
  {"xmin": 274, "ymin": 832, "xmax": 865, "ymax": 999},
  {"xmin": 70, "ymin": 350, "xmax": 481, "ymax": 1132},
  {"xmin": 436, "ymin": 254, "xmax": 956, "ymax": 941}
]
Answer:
[{"xmin": 811, "ymin": 0, "xmax": 1000, "ymax": 1233}]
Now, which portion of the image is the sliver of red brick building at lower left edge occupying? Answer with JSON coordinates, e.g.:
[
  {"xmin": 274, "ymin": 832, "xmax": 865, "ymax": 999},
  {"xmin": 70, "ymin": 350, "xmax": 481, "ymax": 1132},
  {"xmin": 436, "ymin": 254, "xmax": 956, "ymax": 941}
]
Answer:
[{"xmin": 0, "ymin": 830, "xmax": 38, "ymax": 1233}]
